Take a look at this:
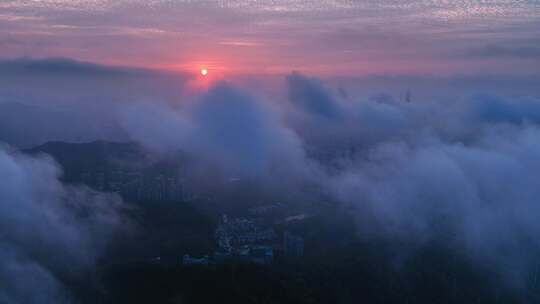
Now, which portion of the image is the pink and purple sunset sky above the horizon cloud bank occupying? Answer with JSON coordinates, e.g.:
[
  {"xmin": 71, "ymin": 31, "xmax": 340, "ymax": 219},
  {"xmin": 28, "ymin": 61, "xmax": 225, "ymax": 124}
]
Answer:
[{"xmin": 0, "ymin": 0, "xmax": 540, "ymax": 76}]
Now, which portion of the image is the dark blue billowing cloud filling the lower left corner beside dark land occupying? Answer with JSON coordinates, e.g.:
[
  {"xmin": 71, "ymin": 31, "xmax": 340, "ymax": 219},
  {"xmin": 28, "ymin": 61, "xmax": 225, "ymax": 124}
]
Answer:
[{"xmin": 0, "ymin": 147, "xmax": 128, "ymax": 303}]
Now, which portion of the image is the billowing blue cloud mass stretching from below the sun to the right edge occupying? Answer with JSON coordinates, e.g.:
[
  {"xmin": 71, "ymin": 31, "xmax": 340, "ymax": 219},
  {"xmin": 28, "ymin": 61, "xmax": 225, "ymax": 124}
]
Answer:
[{"xmin": 121, "ymin": 74, "xmax": 540, "ymax": 284}]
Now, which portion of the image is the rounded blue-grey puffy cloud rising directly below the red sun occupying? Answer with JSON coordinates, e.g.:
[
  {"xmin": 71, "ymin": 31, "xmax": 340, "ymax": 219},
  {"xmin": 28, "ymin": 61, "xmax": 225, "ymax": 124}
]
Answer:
[{"xmin": 121, "ymin": 83, "xmax": 303, "ymax": 177}]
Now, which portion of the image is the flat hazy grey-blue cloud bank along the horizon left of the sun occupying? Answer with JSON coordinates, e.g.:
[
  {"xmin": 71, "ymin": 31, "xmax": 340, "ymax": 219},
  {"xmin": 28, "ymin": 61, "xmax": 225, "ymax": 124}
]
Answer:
[{"xmin": 0, "ymin": 58, "xmax": 189, "ymax": 148}]
